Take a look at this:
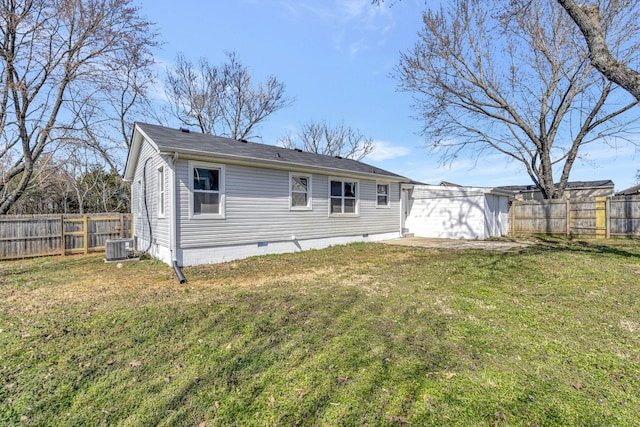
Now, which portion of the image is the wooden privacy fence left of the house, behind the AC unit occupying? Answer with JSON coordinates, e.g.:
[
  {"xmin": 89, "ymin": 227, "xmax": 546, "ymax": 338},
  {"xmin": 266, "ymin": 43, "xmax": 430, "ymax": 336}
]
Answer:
[{"xmin": 0, "ymin": 213, "xmax": 133, "ymax": 260}]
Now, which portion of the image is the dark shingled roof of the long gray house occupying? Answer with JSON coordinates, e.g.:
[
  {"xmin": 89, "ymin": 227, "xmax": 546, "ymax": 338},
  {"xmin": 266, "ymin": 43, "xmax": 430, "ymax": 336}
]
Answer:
[{"xmin": 136, "ymin": 123, "xmax": 409, "ymax": 181}]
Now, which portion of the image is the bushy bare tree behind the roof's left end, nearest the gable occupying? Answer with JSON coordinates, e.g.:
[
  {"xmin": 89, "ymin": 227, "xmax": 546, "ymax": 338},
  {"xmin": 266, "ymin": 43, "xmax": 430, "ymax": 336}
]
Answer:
[{"xmin": 165, "ymin": 52, "xmax": 293, "ymax": 139}]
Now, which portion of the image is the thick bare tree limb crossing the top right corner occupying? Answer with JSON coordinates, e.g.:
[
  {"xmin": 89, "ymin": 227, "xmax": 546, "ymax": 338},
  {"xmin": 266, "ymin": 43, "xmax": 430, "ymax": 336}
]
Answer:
[{"xmin": 557, "ymin": 0, "xmax": 640, "ymax": 101}]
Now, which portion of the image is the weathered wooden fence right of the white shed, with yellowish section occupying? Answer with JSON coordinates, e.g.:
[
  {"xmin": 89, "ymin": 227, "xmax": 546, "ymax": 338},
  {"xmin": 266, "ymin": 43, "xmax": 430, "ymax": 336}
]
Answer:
[{"xmin": 509, "ymin": 196, "xmax": 640, "ymax": 238}]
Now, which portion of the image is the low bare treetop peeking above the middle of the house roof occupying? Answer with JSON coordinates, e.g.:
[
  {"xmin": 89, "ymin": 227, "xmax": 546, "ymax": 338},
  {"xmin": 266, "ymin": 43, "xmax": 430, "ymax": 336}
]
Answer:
[{"xmin": 278, "ymin": 121, "xmax": 375, "ymax": 160}]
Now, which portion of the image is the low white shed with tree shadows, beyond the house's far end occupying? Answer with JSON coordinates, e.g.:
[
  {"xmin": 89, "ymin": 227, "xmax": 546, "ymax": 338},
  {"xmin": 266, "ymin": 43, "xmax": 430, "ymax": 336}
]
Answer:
[{"xmin": 403, "ymin": 183, "xmax": 513, "ymax": 240}]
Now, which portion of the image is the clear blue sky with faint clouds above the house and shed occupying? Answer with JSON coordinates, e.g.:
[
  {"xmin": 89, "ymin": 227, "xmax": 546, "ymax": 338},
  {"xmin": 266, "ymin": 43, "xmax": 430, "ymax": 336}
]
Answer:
[{"xmin": 140, "ymin": 0, "xmax": 640, "ymax": 190}]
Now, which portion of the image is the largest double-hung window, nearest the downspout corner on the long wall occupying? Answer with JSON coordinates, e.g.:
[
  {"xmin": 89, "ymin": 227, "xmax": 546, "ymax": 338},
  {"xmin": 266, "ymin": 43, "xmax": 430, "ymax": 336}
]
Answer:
[{"xmin": 189, "ymin": 162, "xmax": 224, "ymax": 218}]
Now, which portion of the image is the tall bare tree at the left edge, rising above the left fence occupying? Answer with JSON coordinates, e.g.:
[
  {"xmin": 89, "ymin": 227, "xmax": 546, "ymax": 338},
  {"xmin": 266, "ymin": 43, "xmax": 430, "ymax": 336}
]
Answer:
[{"xmin": 0, "ymin": 0, "xmax": 155, "ymax": 214}]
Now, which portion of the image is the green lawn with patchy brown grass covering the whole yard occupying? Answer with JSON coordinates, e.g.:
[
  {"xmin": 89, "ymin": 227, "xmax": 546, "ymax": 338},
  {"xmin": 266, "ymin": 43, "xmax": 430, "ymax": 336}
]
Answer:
[{"xmin": 0, "ymin": 240, "xmax": 640, "ymax": 426}]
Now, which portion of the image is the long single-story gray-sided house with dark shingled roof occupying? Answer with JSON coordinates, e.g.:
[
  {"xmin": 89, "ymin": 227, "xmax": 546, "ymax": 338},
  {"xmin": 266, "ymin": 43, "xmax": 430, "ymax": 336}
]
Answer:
[{"xmin": 124, "ymin": 123, "xmax": 410, "ymax": 266}]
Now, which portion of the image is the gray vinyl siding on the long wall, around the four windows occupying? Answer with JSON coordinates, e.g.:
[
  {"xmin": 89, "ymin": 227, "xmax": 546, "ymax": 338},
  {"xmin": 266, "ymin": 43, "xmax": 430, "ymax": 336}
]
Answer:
[{"xmin": 176, "ymin": 160, "xmax": 400, "ymax": 248}]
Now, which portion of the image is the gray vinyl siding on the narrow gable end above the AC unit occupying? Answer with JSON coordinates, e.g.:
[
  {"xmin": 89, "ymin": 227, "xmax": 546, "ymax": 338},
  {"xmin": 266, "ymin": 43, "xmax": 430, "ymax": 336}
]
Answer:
[{"xmin": 131, "ymin": 141, "xmax": 171, "ymax": 249}]
